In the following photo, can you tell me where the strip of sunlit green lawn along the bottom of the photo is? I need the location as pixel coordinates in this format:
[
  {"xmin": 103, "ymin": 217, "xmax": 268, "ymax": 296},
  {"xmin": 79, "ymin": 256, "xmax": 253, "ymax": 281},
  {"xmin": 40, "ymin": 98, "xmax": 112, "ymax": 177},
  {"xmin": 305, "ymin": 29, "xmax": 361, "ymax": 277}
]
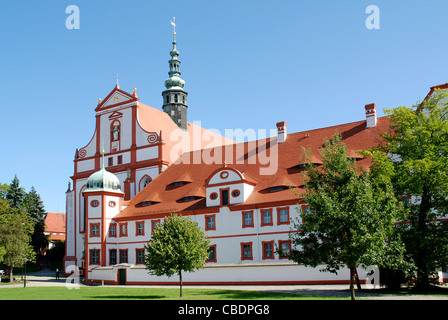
[{"xmin": 0, "ymin": 286, "xmax": 340, "ymax": 300}]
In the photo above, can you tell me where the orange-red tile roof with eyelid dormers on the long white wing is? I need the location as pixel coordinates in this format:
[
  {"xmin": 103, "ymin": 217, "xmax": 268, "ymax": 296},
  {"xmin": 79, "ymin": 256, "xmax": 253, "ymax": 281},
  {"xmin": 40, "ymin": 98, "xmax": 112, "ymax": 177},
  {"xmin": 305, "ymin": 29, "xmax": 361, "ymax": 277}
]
[{"xmin": 116, "ymin": 117, "xmax": 390, "ymax": 220}]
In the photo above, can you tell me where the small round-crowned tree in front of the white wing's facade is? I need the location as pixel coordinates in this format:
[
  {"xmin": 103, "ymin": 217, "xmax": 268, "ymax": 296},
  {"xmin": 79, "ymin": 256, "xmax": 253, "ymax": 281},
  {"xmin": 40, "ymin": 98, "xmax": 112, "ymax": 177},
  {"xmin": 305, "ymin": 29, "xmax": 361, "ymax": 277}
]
[{"xmin": 145, "ymin": 214, "xmax": 210, "ymax": 297}]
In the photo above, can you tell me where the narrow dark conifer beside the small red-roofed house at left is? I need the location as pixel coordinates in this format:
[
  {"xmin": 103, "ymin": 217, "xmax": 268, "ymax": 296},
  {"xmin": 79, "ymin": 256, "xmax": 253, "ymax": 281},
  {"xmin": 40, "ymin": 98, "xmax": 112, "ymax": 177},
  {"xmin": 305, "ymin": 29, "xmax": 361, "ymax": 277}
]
[{"xmin": 24, "ymin": 187, "xmax": 48, "ymax": 252}]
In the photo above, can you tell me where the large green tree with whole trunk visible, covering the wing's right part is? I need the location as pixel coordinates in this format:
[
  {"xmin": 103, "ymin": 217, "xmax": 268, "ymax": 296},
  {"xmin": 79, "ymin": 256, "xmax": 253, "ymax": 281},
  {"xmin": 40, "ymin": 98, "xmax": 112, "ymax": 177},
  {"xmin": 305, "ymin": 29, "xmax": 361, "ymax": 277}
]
[{"xmin": 290, "ymin": 134, "xmax": 403, "ymax": 299}]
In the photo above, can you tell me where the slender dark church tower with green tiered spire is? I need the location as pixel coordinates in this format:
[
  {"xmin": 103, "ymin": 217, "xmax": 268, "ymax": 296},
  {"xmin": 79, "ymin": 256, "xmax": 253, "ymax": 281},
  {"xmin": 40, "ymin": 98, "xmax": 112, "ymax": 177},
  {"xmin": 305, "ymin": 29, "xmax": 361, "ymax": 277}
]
[{"xmin": 162, "ymin": 18, "xmax": 188, "ymax": 130}]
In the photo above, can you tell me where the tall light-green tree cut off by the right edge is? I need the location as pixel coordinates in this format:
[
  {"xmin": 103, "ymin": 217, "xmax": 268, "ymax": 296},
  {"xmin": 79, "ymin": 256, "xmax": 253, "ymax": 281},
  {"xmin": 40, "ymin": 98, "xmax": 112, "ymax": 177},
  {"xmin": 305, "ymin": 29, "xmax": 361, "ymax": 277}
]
[{"xmin": 376, "ymin": 90, "xmax": 448, "ymax": 290}]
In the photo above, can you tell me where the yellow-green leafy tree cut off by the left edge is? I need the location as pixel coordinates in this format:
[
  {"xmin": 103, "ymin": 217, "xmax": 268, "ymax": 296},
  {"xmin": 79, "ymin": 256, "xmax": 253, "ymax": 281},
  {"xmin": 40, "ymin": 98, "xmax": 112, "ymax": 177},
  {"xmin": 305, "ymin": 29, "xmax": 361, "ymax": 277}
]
[{"xmin": 0, "ymin": 199, "xmax": 35, "ymax": 281}]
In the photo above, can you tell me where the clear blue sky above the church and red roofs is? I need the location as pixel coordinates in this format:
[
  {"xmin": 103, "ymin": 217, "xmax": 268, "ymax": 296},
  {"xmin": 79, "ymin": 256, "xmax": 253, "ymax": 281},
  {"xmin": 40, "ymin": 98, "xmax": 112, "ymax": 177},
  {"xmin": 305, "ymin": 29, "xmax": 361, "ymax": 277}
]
[{"xmin": 0, "ymin": 0, "xmax": 448, "ymax": 212}]
